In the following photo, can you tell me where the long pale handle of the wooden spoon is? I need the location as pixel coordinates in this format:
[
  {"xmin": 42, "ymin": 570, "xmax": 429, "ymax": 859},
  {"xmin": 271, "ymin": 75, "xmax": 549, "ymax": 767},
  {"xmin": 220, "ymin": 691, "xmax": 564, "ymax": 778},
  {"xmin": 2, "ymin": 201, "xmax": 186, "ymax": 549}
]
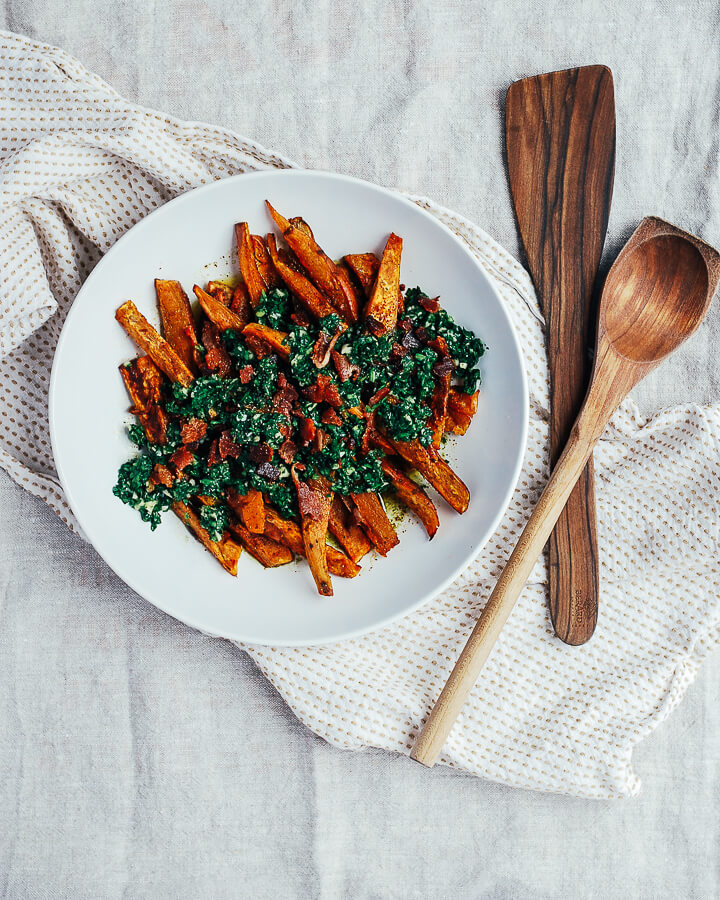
[{"xmin": 410, "ymin": 413, "xmax": 602, "ymax": 766}]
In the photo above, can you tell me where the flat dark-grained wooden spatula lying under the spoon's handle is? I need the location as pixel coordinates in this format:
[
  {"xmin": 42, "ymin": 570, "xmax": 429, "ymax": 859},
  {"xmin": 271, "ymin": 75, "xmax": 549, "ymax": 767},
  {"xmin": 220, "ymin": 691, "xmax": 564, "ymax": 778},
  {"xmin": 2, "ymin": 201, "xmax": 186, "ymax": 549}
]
[{"xmin": 505, "ymin": 66, "xmax": 615, "ymax": 644}]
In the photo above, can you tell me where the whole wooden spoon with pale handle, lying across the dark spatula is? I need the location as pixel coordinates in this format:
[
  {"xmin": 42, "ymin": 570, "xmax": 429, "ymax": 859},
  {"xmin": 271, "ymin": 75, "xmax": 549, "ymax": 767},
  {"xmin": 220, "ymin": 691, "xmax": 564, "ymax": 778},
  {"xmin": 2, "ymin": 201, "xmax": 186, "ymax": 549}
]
[{"xmin": 410, "ymin": 217, "xmax": 720, "ymax": 766}]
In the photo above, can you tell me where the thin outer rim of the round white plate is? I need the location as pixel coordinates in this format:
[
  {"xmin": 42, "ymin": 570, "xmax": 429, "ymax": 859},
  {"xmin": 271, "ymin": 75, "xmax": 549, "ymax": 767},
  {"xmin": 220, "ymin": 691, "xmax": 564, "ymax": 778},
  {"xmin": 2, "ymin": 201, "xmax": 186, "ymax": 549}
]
[{"xmin": 48, "ymin": 168, "xmax": 530, "ymax": 647}]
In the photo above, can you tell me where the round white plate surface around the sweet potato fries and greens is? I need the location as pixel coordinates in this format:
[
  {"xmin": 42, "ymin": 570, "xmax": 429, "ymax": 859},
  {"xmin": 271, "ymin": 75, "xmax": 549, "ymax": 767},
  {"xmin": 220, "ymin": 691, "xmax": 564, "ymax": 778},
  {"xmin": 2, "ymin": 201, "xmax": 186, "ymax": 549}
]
[{"xmin": 50, "ymin": 170, "xmax": 528, "ymax": 646}]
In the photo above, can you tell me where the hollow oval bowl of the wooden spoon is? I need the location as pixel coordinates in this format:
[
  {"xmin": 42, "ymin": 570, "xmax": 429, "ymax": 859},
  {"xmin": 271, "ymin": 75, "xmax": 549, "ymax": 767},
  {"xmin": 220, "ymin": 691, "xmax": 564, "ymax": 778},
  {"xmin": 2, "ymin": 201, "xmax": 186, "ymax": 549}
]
[{"xmin": 600, "ymin": 234, "xmax": 710, "ymax": 364}]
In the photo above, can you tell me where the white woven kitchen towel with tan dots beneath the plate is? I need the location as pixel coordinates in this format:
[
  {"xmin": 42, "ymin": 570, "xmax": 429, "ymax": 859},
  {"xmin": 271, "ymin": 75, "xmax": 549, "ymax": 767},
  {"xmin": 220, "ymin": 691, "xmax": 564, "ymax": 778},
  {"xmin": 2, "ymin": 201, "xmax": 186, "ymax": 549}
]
[{"xmin": 0, "ymin": 33, "xmax": 720, "ymax": 797}]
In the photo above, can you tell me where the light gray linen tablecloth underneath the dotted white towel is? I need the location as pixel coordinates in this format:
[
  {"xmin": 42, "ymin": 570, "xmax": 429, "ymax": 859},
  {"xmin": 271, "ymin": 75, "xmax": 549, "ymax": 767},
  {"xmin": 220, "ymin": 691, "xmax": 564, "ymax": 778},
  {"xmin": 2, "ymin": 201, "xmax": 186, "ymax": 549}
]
[{"xmin": 0, "ymin": 0, "xmax": 720, "ymax": 900}]
